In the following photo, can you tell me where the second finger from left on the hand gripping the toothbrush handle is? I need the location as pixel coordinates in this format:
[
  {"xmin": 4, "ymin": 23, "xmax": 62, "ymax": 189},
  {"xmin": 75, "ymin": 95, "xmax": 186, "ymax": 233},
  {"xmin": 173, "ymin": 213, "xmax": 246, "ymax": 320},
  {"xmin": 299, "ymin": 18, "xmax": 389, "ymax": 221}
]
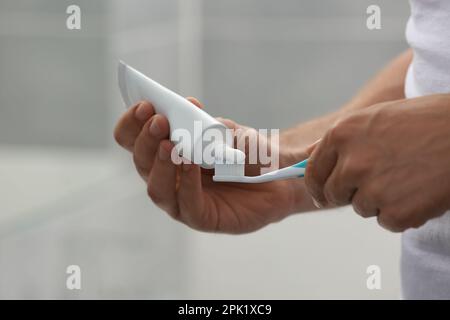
[{"xmin": 323, "ymin": 161, "xmax": 357, "ymax": 206}]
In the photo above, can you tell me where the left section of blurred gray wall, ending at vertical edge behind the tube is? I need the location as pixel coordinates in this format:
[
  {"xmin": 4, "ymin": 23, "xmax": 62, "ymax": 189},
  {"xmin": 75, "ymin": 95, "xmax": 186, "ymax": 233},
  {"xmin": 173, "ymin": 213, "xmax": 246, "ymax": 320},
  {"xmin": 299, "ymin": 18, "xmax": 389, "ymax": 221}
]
[{"xmin": 0, "ymin": 0, "xmax": 188, "ymax": 299}]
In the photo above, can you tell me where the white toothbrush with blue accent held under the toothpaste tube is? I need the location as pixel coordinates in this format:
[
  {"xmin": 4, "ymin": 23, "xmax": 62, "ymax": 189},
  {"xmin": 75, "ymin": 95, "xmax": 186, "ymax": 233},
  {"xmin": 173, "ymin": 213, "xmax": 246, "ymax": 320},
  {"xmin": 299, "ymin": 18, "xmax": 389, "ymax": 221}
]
[{"xmin": 213, "ymin": 159, "xmax": 308, "ymax": 183}]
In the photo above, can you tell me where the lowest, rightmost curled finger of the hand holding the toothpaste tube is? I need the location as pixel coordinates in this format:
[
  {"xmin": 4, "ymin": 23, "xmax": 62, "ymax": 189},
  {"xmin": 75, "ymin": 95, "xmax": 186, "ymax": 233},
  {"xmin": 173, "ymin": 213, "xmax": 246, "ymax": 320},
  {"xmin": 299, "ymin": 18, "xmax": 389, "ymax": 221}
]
[{"xmin": 177, "ymin": 163, "xmax": 210, "ymax": 230}]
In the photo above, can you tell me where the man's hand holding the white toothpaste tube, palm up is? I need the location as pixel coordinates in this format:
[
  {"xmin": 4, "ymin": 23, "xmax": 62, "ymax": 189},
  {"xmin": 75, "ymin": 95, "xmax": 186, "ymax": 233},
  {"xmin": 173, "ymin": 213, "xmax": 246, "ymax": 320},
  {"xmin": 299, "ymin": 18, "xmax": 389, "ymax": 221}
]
[{"xmin": 114, "ymin": 98, "xmax": 312, "ymax": 233}]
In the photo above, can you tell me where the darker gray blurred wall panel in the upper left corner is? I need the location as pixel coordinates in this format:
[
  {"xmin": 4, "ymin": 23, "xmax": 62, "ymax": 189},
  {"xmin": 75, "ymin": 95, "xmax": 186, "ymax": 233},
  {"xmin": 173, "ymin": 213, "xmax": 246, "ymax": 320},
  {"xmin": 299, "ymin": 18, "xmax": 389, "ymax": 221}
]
[{"xmin": 0, "ymin": 0, "xmax": 108, "ymax": 147}]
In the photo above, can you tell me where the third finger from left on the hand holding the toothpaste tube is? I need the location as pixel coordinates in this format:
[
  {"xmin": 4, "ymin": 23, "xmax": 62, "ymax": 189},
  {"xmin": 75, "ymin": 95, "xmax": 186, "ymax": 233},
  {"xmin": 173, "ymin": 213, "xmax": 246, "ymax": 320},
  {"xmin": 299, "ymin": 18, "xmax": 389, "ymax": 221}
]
[{"xmin": 147, "ymin": 140, "xmax": 179, "ymax": 219}]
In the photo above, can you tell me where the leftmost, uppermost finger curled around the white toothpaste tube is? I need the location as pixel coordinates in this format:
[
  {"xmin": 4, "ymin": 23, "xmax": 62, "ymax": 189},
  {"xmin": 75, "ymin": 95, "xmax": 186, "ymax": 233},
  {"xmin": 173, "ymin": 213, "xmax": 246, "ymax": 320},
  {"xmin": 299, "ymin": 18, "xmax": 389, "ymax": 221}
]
[{"xmin": 114, "ymin": 101, "xmax": 155, "ymax": 151}]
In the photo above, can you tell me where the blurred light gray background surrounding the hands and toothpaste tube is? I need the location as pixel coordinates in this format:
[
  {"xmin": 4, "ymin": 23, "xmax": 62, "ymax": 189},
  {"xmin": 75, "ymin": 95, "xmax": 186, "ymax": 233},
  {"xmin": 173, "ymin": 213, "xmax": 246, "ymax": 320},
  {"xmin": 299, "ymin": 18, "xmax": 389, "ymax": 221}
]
[{"xmin": 0, "ymin": 0, "xmax": 409, "ymax": 299}]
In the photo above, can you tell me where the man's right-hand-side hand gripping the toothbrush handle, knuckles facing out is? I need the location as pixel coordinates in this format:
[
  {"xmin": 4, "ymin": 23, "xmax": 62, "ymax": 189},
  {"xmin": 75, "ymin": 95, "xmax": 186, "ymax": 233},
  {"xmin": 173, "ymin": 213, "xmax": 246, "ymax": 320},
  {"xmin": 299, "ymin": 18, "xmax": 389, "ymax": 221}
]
[{"xmin": 305, "ymin": 95, "xmax": 450, "ymax": 232}]
